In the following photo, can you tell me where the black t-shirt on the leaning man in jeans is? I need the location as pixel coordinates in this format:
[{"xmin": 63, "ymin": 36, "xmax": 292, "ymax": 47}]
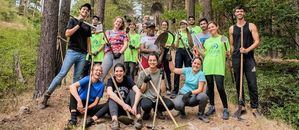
[{"xmin": 67, "ymin": 18, "xmax": 91, "ymax": 54}]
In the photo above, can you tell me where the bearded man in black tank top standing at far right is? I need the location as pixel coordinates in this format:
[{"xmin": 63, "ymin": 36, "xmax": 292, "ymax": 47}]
[{"xmin": 229, "ymin": 5, "xmax": 260, "ymax": 116}]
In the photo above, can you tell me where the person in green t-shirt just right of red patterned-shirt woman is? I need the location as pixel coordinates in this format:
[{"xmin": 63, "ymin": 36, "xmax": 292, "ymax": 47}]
[{"xmin": 124, "ymin": 22, "xmax": 140, "ymax": 81}]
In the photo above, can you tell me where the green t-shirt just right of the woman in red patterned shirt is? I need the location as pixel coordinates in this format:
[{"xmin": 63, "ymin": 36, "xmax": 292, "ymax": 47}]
[{"xmin": 124, "ymin": 33, "xmax": 140, "ymax": 62}]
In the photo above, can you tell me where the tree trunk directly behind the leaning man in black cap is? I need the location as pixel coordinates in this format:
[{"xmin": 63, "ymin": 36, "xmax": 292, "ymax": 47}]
[{"xmin": 55, "ymin": 0, "xmax": 71, "ymax": 74}]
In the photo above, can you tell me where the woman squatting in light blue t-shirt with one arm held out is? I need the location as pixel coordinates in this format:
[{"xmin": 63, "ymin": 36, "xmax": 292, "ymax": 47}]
[{"xmin": 169, "ymin": 58, "xmax": 209, "ymax": 123}]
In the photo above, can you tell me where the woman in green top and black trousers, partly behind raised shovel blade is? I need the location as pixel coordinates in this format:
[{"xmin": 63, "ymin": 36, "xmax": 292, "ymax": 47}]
[{"xmin": 157, "ymin": 20, "xmax": 175, "ymax": 95}]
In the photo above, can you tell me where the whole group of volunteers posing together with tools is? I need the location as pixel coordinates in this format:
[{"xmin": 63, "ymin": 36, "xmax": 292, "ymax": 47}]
[{"xmin": 41, "ymin": 4, "xmax": 259, "ymax": 129}]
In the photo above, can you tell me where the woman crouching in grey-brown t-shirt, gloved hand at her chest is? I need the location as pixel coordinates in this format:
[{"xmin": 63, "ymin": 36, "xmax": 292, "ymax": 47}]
[{"xmin": 137, "ymin": 53, "xmax": 174, "ymax": 120}]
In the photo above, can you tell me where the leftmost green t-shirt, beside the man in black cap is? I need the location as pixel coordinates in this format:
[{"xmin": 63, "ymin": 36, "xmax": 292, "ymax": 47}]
[{"xmin": 86, "ymin": 33, "xmax": 105, "ymax": 62}]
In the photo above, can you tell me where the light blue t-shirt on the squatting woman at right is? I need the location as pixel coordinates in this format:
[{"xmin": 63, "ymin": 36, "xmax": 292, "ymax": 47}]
[{"xmin": 180, "ymin": 67, "xmax": 206, "ymax": 94}]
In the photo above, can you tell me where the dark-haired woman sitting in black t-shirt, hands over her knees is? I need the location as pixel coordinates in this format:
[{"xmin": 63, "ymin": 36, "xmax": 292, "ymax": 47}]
[{"xmin": 107, "ymin": 63, "xmax": 143, "ymax": 130}]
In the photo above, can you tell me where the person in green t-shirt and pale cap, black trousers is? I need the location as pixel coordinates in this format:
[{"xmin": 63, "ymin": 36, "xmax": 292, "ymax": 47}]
[{"xmin": 170, "ymin": 20, "xmax": 193, "ymax": 98}]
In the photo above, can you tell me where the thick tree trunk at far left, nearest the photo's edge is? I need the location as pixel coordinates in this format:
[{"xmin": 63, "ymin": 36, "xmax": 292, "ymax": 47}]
[{"xmin": 33, "ymin": 0, "xmax": 59, "ymax": 98}]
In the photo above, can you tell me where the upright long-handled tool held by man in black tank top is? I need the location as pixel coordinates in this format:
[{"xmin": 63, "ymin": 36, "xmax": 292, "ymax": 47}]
[{"xmin": 234, "ymin": 27, "xmax": 244, "ymax": 120}]
